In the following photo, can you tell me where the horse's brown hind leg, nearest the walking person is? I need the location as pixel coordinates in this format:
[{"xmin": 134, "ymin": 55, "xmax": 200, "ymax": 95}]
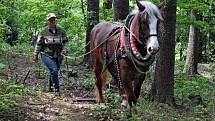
[{"xmin": 94, "ymin": 69, "xmax": 109, "ymax": 103}]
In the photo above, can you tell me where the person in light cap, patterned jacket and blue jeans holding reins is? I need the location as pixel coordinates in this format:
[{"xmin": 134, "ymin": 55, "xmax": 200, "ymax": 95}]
[{"xmin": 34, "ymin": 13, "xmax": 68, "ymax": 96}]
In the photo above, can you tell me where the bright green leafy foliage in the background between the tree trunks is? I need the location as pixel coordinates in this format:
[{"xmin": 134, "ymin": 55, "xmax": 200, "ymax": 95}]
[{"xmin": 0, "ymin": 0, "xmax": 215, "ymax": 60}]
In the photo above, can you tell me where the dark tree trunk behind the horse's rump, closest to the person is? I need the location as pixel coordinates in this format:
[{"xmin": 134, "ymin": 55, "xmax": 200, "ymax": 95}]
[{"xmin": 83, "ymin": 0, "xmax": 99, "ymax": 64}]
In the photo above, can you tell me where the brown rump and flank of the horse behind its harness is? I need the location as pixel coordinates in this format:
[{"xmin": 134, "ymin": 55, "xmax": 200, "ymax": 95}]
[{"xmin": 90, "ymin": 22, "xmax": 121, "ymax": 74}]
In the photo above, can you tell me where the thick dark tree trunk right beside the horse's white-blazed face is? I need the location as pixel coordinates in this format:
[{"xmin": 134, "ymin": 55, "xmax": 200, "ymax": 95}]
[{"xmin": 151, "ymin": 0, "xmax": 176, "ymax": 105}]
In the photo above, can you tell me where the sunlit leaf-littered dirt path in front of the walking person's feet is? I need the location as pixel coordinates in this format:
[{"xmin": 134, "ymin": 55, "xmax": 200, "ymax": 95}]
[{"xmin": 22, "ymin": 93, "xmax": 98, "ymax": 121}]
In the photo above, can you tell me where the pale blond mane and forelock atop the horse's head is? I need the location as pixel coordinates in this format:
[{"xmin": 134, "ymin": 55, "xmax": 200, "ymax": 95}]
[{"xmin": 132, "ymin": 1, "xmax": 163, "ymax": 20}]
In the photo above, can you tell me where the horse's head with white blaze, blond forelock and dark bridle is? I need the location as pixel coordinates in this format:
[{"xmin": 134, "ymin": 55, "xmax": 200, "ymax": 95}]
[{"xmin": 134, "ymin": 0, "xmax": 163, "ymax": 59}]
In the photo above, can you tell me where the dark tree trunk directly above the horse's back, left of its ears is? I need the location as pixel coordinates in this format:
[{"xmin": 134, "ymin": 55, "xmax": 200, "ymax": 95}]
[{"xmin": 113, "ymin": 0, "xmax": 129, "ymax": 21}]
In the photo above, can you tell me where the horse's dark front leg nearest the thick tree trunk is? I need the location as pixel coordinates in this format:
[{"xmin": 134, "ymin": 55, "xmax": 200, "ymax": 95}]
[{"xmin": 134, "ymin": 74, "xmax": 146, "ymax": 99}]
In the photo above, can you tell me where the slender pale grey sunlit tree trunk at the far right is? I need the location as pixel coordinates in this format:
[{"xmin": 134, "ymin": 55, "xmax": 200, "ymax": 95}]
[{"xmin": 183, "ymin": 11, "xmax": 200, "ymax": 79}]
